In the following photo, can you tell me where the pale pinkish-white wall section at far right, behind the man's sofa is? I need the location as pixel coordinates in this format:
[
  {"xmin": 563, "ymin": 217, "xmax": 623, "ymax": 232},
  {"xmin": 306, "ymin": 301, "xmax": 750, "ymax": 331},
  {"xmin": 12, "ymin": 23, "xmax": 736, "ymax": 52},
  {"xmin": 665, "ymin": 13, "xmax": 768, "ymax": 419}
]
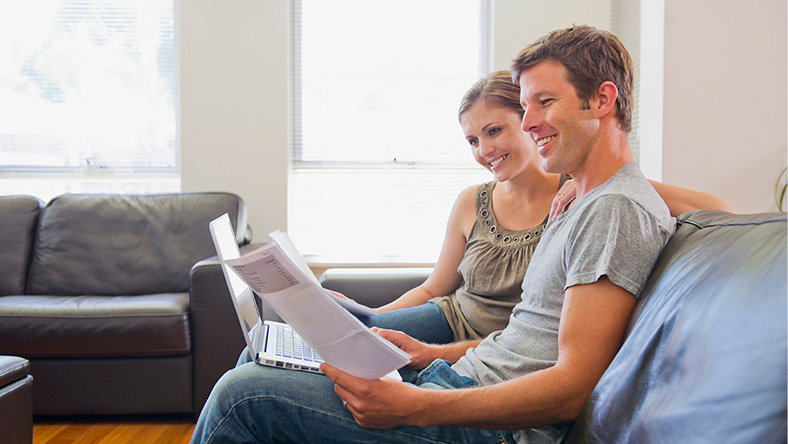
[{"xmin": 663, "ymin": 0, "xmax": 788, "ymax": 213}]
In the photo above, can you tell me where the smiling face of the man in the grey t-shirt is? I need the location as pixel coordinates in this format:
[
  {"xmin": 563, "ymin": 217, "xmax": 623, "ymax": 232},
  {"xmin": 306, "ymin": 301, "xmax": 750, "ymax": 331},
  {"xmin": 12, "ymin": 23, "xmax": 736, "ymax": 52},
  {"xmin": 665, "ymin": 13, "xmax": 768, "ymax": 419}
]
[{"xmin": 520, "ymin": 61, "xmax": 599, "ymax": 174}]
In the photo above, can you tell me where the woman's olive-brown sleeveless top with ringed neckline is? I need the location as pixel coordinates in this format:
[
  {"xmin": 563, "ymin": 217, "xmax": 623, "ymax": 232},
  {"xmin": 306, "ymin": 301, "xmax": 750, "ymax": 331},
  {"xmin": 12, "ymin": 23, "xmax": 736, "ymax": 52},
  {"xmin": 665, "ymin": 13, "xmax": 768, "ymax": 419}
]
[{"xmin": 432, "ymin": 177, "xmax": 566, "ymax": 341}]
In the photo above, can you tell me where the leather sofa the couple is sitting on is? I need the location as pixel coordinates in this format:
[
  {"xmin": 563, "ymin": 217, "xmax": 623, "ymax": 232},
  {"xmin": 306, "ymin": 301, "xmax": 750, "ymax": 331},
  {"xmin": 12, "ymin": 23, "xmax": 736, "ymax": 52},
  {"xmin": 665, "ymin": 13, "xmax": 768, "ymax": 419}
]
[{"xmin": 321, "ymin": 210, "xmax": 788, "ymax": 444}]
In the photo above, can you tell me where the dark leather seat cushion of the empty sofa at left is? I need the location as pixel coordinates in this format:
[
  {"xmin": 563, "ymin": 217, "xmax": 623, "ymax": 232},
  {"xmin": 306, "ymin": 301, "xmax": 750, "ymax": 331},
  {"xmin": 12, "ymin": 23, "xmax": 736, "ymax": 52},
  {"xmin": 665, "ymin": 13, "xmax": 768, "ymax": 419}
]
[{"xmin": 0, "ymin": 293, "xmax": 191, "ymax": 358}]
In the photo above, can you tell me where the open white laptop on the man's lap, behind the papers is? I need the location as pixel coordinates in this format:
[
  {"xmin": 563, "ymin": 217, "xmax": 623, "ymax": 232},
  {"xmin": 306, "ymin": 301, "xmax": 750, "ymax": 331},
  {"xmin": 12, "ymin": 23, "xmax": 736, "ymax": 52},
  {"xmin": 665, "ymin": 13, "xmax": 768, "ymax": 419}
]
[{"xmin": 210, "ymin": 214, "xmax": 323, "ymax": 373}]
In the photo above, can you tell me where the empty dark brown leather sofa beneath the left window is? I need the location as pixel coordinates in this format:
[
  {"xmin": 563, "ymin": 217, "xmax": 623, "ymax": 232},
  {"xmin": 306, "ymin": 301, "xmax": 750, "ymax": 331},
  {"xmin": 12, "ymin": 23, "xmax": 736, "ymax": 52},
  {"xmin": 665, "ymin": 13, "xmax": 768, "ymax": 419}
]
[{"xmin": 0, "ymin": 193, "xmax": 251, "ymax": 415}]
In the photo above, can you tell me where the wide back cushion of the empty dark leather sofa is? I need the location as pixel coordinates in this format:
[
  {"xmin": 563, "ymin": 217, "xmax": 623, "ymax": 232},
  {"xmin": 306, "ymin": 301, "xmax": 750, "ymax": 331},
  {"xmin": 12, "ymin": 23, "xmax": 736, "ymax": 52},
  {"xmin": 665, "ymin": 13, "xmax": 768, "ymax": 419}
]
[{"xmin": 27, "ymin": 193, "xmax": 246, "ymax": 296}]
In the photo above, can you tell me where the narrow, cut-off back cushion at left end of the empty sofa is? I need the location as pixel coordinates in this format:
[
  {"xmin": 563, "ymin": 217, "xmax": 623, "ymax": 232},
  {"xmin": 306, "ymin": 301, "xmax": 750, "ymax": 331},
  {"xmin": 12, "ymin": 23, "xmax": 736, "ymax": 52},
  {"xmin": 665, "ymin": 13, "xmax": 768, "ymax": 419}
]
[{"xmin": 0, "ymin": 196, "xmax": 43, "ymax": 296}]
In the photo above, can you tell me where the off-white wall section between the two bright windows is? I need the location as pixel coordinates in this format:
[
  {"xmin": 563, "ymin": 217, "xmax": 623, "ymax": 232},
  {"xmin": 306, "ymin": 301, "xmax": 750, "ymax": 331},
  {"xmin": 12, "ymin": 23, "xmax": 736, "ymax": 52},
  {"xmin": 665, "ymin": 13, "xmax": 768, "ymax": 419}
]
[{"xmin": 177, "ymin": 0, "xmax": 289, "ymax": 236}]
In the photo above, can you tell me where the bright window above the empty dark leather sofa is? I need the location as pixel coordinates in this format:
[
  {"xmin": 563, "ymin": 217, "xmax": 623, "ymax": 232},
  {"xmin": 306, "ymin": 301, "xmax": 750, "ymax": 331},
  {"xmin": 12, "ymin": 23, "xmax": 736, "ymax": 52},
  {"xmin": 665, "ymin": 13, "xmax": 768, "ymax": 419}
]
[{"xmin": 0, "ymin": 0, "xmax": 180, "ymax": 200}]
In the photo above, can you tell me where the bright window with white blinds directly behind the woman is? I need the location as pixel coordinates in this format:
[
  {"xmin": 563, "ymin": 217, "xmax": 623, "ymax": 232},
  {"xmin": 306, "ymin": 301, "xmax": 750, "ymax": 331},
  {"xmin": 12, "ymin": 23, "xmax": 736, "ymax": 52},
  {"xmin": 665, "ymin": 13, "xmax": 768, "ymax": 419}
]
[{"xmin": 288, "ymin": 0, "xmax": 491, "ymax": 264}]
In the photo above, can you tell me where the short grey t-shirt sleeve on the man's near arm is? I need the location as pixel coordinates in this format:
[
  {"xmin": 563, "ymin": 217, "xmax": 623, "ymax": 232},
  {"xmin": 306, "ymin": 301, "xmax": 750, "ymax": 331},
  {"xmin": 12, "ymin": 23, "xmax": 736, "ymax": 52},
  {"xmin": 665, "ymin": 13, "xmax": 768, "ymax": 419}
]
[{"xmin": 564, "ymin": 194, "xmax": 669, "ymax": 296}]
